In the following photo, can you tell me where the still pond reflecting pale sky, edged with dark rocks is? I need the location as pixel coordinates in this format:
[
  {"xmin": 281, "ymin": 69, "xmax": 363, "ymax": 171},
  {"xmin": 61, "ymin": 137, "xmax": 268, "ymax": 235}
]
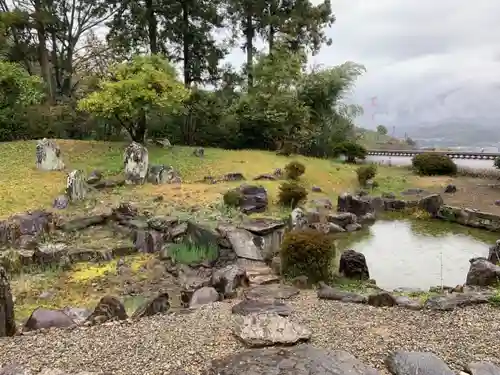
[{"xmin": 338, "ymin": 220, "xmax": 499, "ymax": 290}]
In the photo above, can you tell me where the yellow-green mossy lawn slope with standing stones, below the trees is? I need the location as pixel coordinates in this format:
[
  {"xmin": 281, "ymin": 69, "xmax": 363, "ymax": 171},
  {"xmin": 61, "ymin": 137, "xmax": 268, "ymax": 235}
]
[{"xmin": 0, "ymin": 140, "xmax": 425, "ymax": 218}]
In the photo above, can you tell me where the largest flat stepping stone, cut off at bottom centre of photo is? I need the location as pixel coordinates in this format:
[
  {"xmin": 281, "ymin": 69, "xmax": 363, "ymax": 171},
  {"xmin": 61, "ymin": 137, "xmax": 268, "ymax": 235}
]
[{"xmin": 203, "ymin": 344, "xmax": 378, "ymax": 375}]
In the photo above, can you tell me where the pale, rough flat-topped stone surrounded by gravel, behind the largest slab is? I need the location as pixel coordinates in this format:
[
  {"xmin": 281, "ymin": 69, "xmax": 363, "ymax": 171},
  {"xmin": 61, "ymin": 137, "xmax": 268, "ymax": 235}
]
[{"xmin": 233, "ymin": 313, "xmax": 311, "ymax": 347}]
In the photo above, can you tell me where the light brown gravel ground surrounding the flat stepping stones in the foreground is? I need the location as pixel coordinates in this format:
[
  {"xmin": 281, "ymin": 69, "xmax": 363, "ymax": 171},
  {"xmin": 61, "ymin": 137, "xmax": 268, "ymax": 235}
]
[{"xmin": 0, "ymin": 292, "xmax": 500, "ymax": 375}]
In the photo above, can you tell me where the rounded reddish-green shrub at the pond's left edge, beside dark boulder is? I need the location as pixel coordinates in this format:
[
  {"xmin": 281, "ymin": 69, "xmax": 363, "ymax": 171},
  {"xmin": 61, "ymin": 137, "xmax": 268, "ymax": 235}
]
[{"xmin": 280, "ymin": 229, "xmax": 336, "ymax": 283}]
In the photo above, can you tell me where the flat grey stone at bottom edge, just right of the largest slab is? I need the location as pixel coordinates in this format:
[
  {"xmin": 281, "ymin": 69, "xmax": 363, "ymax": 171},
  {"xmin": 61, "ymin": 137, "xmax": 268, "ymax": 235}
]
[{"xmin": 384, "ymin": 351, "xmax": 454, "ymax": 375}]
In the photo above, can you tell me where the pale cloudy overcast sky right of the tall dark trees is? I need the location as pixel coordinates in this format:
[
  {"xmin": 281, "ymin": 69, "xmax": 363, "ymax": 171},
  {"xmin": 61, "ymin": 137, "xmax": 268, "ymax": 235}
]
[{"xmin": 229, "ymin": 0, "xmax": 500, "ymax": 130}]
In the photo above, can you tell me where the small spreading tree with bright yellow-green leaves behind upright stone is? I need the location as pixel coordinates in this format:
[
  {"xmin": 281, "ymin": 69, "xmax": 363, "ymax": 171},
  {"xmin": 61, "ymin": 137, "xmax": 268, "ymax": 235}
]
[{"xmin": 78, "ymin": 55, "xmax": 189, "ymax": 143}]
